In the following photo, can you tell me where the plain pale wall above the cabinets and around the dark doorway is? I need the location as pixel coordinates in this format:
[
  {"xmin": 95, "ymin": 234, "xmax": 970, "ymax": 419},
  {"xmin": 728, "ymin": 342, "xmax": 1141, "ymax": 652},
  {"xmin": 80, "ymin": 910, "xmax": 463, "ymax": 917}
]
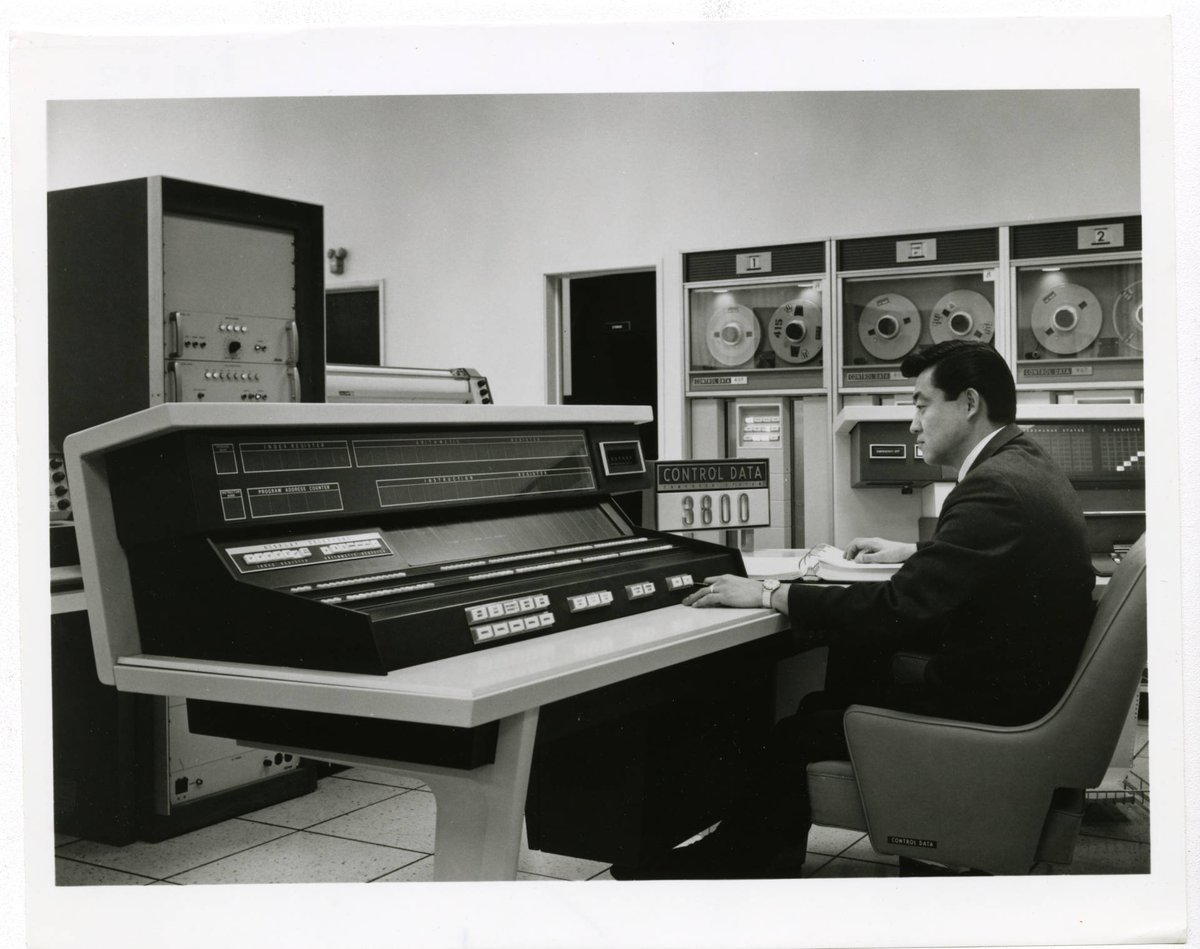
[{"xmin": 48, "ymin": 90, "xmax": 1140, "ymax": 457}]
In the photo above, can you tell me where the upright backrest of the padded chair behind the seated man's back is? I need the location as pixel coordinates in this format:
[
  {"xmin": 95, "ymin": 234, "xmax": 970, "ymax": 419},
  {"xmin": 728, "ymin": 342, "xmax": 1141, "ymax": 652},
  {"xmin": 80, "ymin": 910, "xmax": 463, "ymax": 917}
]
[{"xmin": 1036, "ymin": 535, "xmax": 1146, "ymax": 788}]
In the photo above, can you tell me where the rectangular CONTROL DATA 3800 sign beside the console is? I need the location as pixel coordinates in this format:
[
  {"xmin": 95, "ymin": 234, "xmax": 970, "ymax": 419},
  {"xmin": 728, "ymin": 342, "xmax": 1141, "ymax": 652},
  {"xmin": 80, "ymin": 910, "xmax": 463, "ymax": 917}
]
[{"xmin": 654, "ymin": 458, "xmax": 770, "ymax": 530}]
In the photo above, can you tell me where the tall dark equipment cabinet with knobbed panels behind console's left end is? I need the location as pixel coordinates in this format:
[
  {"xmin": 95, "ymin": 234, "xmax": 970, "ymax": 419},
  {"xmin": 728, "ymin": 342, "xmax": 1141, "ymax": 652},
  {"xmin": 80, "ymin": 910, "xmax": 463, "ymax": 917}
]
[{"xmin": 47, "ymin": 176, "xmax": 325, "ymax": 843}]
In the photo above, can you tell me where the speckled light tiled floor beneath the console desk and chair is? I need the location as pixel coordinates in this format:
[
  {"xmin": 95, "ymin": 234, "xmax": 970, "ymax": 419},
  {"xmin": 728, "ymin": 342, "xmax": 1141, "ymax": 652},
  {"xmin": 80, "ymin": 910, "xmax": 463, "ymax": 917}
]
[{"xmin": 55, "ymin": 728, "xmax": 1150, "ymax": 887}]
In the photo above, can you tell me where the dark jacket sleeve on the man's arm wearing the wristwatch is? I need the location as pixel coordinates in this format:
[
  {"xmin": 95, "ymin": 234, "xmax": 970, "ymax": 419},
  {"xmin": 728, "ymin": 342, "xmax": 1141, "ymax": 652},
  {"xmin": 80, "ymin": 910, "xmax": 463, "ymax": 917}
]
[{"xmin": 788, "ymin": 472, "xmax": 1027, "ymax": 645}]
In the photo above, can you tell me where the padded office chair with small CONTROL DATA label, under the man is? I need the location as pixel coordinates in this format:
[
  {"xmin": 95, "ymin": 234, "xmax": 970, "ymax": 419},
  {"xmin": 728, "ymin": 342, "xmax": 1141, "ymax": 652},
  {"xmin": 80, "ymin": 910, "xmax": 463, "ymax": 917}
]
[{"xmin": 808, "ymin": 535, "xmax": 1146, "ymax": 873}]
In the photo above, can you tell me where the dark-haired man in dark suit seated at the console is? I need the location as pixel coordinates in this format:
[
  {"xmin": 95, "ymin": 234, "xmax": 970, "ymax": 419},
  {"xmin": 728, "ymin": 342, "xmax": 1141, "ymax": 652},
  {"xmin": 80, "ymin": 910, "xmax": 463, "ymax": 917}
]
[{"xmin": 613, "ymin": 341, "xmax": 1094, "ymax": 878}]
